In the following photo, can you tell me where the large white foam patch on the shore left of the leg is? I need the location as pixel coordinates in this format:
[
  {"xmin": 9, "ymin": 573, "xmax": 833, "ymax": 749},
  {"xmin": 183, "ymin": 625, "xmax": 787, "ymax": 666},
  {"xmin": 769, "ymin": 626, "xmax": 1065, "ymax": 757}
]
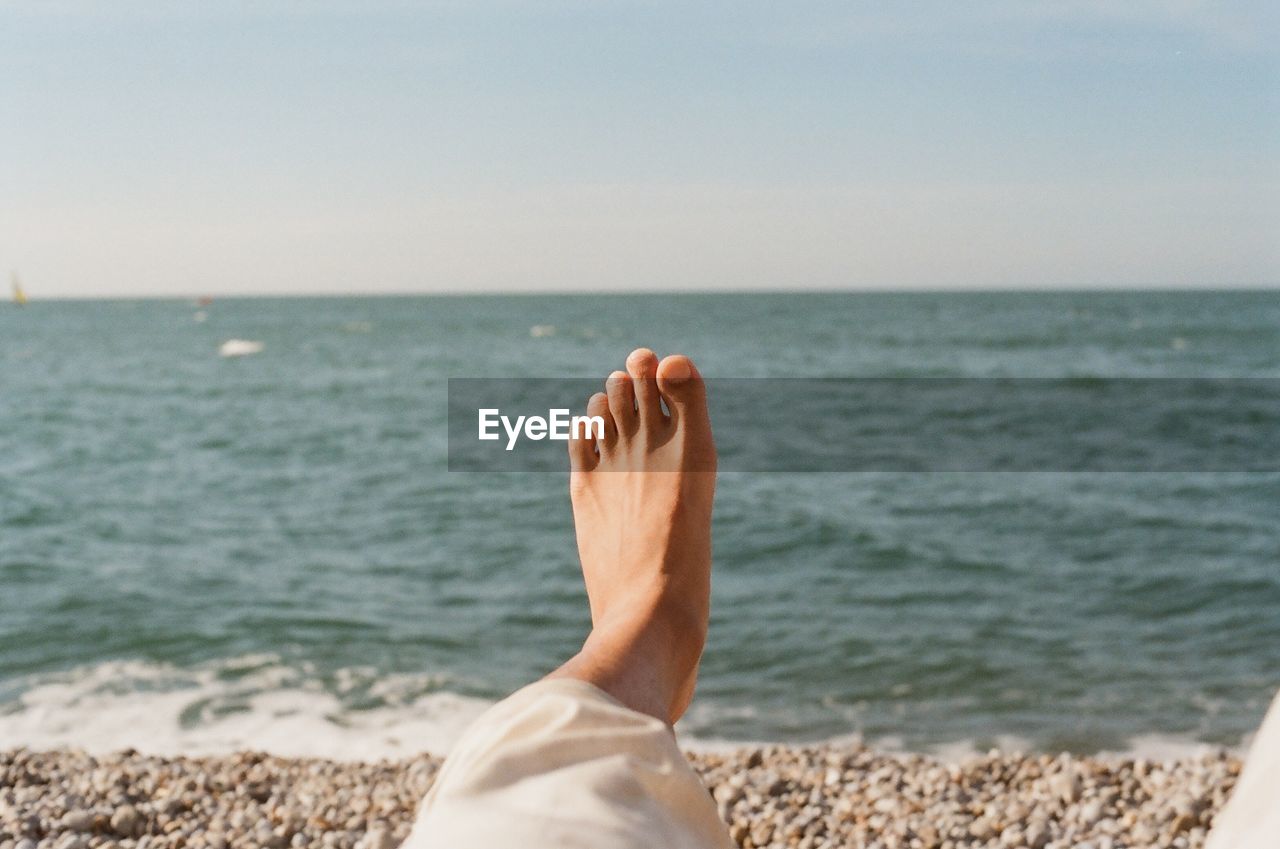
[{"xmin": 0, "ymin": 656, "xmax": 488, "ymax": 761}]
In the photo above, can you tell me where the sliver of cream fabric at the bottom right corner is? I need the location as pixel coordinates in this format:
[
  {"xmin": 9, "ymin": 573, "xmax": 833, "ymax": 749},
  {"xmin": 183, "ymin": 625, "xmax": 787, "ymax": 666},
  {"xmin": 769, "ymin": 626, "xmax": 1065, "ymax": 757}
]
[{"xmin": 1204, "ymin": 693, "xmax": 1280, "ymax": 849}]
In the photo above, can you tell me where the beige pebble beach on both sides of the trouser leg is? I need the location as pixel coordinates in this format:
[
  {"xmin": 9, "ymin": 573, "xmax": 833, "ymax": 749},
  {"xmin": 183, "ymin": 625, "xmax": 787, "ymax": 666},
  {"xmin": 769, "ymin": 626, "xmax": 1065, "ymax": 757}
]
[{"xmin": 0, "ymin": 744, "xmax": 1240, "ymax": 849}]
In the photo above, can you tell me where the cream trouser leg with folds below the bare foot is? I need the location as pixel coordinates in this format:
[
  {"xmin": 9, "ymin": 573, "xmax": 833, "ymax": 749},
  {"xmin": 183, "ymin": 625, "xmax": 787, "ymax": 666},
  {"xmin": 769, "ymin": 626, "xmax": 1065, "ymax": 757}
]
[{"xmin": 404, "ymin": 679, "xmax": 733, "ymax": 849}]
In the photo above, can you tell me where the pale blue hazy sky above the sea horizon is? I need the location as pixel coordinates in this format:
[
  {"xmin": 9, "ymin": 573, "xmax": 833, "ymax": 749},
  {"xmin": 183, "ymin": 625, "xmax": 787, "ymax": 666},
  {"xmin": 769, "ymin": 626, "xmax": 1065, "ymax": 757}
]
[{"xmin": 0, "ymin": 0, "xmax": 1280, "ymax": 297}]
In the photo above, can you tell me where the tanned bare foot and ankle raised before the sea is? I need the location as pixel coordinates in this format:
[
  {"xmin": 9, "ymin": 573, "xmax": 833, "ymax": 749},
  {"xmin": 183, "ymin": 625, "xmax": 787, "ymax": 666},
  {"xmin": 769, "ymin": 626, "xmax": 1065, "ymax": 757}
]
[{"xmin": 552, "ymin": 348, "xmax": 716, "ymax": 724}]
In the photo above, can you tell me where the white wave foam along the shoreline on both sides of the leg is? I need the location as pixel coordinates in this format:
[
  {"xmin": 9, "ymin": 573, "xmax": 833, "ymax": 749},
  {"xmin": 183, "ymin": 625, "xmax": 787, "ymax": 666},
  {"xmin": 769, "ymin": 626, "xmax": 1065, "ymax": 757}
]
[{"xmin": 0, "ymin": 654, "xmax": 1247, "ymax": 762}]
